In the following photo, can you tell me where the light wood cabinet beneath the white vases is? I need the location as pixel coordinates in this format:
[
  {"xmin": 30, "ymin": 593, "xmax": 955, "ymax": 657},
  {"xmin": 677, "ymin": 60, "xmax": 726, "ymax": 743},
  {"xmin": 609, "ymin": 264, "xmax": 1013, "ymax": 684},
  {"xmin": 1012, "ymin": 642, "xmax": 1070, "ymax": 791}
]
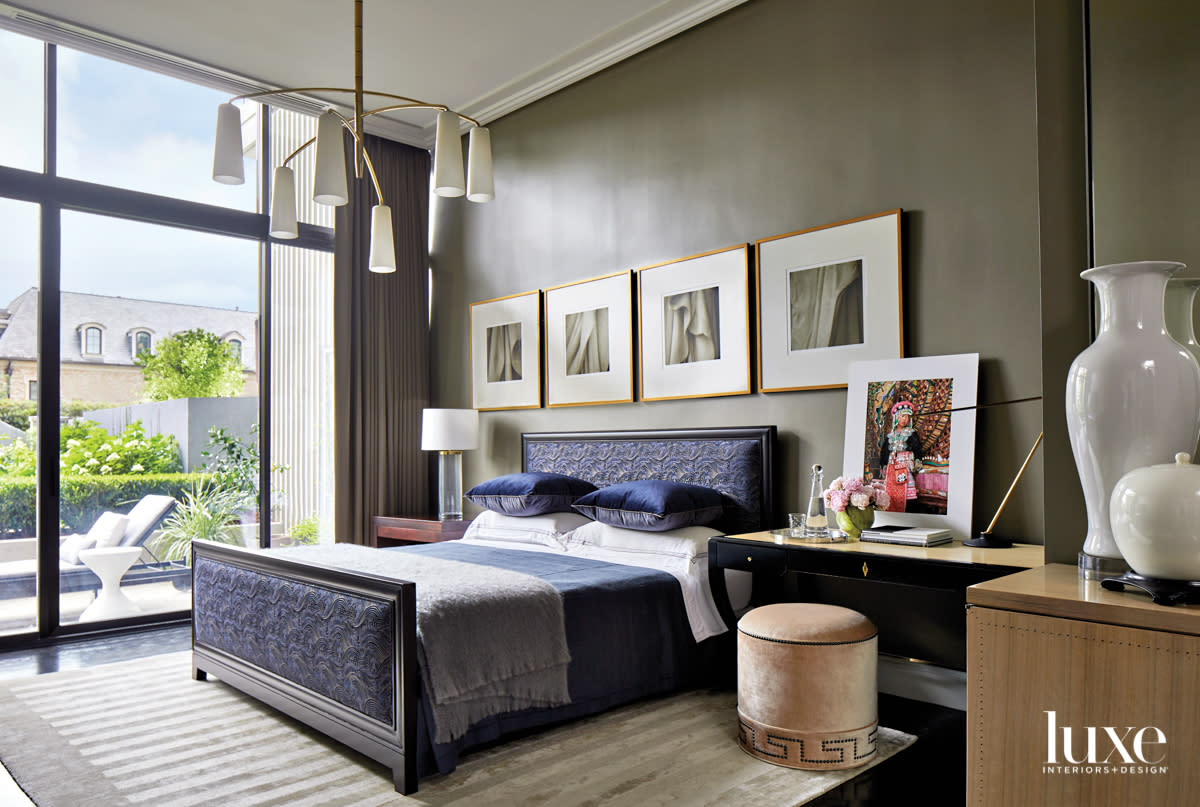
[{"xmin": 967, "ymin": 564, "xmax": 1200, "ymax": 807}]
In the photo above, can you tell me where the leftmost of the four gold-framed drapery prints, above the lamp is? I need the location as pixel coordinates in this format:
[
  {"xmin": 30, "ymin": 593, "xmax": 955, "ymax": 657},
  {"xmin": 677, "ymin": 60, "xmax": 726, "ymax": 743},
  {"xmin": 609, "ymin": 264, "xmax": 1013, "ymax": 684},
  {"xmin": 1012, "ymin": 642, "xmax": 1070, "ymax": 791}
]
[{"xmin": 470, "ymin": 292, "xmax": 541, "ymax": 410}]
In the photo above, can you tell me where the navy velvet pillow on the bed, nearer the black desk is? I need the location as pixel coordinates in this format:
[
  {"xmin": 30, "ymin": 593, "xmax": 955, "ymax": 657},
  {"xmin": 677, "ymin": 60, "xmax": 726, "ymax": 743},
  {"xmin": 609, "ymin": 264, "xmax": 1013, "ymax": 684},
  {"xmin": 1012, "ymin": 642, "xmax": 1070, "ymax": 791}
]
[{"xmin": 574, "ymin": 479, "xmax": 724, "ymax": 532}]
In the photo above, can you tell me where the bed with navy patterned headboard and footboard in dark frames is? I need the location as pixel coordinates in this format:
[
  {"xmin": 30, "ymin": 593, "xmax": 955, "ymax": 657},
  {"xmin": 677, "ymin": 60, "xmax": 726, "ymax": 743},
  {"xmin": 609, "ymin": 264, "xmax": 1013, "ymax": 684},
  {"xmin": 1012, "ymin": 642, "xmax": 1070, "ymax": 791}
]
[{"xmin": 192, "ymin": 426, "xmax": 775, "ymax": 793}]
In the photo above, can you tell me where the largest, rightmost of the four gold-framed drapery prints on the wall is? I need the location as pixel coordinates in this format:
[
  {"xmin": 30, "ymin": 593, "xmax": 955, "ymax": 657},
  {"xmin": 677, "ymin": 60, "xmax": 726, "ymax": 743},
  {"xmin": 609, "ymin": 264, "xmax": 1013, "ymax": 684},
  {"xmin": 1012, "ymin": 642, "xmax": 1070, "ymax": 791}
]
[{"xmin": 755, "ymin": 210, "xmax": 904, "ymax": 393}]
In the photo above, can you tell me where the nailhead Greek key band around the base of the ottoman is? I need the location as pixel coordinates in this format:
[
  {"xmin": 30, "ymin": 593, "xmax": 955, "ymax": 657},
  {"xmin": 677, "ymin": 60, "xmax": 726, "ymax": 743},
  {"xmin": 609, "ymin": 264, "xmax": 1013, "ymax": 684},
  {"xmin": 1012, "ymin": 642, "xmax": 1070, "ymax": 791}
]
[{"xmin": 738, "ymin": 709, "xmax": 880, "ymax": 770}]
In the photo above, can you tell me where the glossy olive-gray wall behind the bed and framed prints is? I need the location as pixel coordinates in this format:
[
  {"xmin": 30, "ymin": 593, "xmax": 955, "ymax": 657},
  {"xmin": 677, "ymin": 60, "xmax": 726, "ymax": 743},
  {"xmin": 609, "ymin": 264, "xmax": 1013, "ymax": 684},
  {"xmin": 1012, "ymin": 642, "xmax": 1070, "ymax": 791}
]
[{"xmin": 432, "ymin": 0, "xmax": 1086, "ymax": 552}]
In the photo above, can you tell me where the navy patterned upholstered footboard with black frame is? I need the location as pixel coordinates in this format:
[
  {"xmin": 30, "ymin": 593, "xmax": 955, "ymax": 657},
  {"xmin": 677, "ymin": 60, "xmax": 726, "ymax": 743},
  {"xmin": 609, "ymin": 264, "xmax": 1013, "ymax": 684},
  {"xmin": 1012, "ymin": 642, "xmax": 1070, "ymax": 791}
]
[{"xmin": 184, "ymin": 540, "xmax": 420, "ymax": 793}]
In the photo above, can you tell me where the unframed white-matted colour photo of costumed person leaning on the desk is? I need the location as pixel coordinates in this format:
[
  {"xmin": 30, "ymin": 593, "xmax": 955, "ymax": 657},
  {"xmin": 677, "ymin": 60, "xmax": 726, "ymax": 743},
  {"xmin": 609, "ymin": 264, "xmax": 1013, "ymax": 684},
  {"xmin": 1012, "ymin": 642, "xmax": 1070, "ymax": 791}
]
[{"xmin": 842, "ymin": 353, "xmax": 979, "ymax": 539}]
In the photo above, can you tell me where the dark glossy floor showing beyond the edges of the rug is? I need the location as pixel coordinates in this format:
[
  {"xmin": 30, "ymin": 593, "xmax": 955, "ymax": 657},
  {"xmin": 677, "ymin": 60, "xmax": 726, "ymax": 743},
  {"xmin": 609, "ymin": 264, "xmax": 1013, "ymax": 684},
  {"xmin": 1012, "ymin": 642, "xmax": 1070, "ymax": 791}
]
[{"xmin": 0, "ymin": 624, "xmax": 966, "ymax": 807}]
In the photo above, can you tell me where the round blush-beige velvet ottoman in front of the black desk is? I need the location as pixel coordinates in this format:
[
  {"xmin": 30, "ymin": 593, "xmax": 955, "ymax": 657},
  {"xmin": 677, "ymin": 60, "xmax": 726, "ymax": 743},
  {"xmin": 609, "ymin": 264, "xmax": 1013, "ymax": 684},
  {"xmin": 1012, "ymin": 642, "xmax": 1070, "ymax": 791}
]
[{"xmin": 738, "ymin": 603, "xmax": 878, "ymax": 770}]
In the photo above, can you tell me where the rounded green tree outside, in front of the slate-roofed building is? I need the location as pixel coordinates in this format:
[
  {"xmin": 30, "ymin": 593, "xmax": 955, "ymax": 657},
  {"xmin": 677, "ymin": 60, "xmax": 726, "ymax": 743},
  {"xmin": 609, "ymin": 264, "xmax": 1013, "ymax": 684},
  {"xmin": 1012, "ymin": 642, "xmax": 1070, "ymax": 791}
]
[{"xmin": 137, "ymin": 328, "xmax": 246, "ymax": 401}]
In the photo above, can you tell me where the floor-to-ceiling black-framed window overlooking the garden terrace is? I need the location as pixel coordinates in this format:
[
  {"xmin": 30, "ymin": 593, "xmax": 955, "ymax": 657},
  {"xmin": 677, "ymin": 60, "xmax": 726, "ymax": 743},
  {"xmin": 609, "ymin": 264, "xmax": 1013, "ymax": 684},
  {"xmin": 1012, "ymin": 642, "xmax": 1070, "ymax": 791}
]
[{"xmin": 0, "ymin": 30, "xmax": 332, "ymax": 639}]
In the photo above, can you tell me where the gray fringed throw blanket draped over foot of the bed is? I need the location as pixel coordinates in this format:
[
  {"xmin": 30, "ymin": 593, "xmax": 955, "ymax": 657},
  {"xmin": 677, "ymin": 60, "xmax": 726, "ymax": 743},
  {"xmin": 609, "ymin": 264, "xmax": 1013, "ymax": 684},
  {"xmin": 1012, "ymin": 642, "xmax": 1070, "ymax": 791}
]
[{"xmin": 277, "ymin": 544, "xmax": 571, "ymax": 742}]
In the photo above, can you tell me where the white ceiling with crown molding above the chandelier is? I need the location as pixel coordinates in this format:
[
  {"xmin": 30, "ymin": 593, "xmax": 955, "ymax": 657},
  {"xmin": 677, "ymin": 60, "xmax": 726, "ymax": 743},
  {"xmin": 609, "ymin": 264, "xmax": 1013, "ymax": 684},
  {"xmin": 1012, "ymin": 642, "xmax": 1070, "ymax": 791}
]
[{"xmin": 0, "ymin": 0, "xmax": 744, "ymax": 145}]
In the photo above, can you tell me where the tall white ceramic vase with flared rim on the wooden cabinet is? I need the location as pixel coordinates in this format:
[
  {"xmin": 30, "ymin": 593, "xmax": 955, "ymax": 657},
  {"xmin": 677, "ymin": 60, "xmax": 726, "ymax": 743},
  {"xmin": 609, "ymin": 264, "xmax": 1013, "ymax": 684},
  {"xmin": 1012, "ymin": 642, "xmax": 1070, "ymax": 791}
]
[{"xmin": 1067, "ymin": 261, "xmax": 1200, "ymax": 558}]
